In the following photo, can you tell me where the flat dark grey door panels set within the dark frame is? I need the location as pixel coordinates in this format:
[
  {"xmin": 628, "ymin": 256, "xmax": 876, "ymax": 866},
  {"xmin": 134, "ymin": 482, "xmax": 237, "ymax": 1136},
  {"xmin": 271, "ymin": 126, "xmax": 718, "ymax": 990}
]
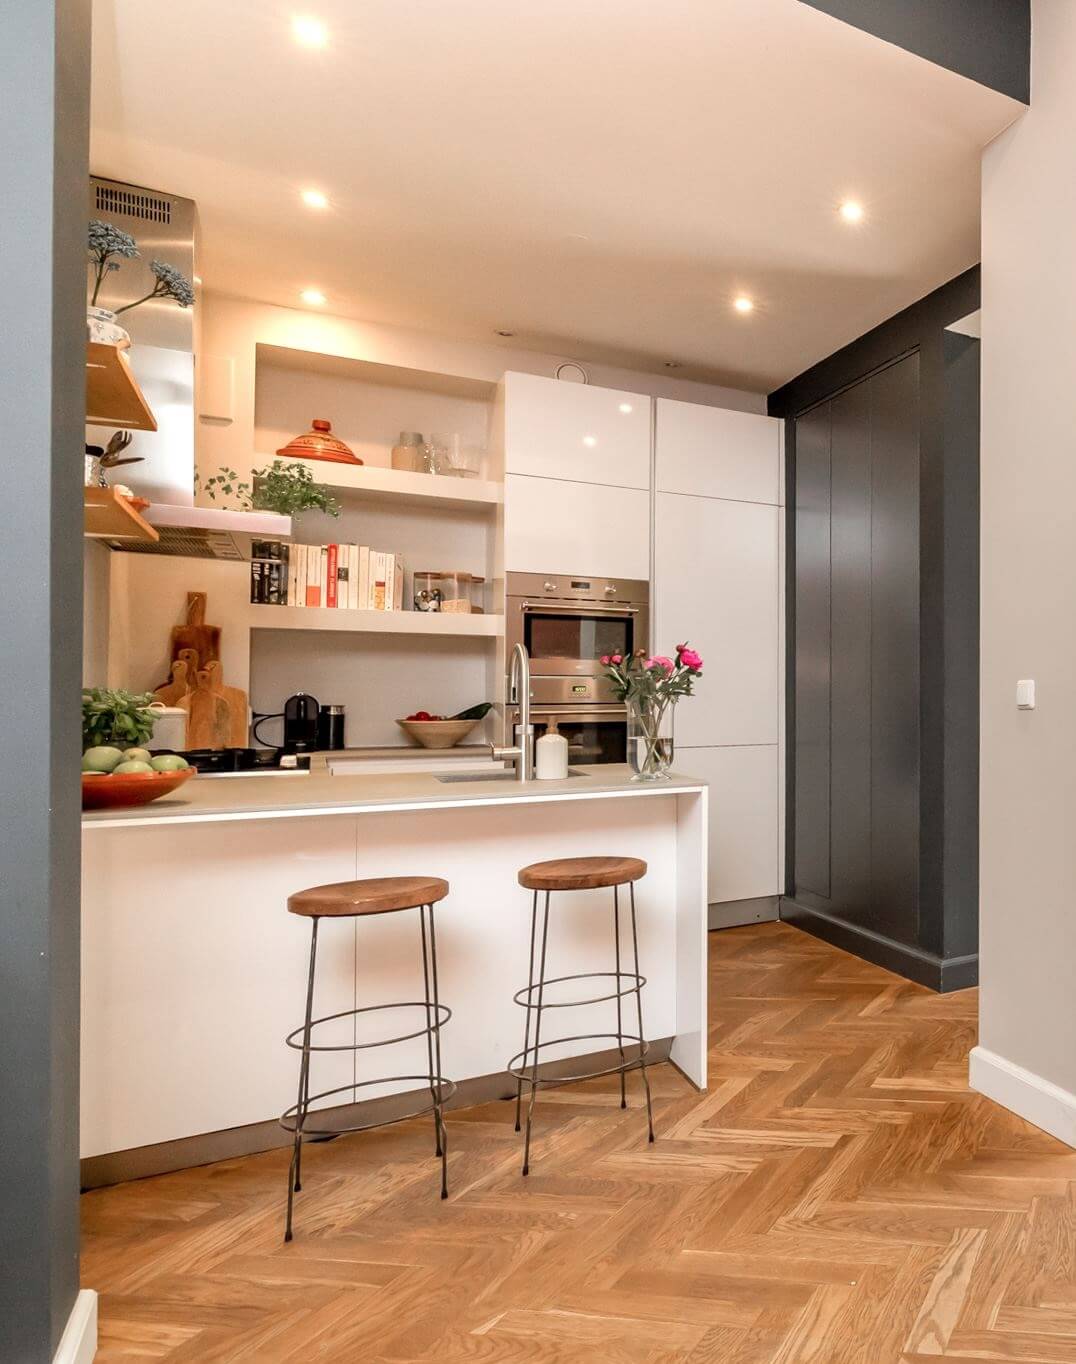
[{"xmin": 791, "ymin": 355, "xmax": 919, "ymax": 943}]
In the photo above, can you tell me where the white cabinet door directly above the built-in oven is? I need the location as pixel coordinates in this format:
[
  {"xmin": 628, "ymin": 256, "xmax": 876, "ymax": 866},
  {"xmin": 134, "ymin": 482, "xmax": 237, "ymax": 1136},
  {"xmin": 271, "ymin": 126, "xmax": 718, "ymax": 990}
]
[{"xmin": 505, "ymin": 473, "xmax": 651, "ymax": 580}]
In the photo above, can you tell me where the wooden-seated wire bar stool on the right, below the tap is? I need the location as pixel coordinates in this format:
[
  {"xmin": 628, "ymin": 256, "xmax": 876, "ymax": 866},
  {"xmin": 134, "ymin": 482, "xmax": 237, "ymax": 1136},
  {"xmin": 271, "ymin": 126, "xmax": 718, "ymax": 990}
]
[{"xmin": 507, "ymin": 857, "xmax": 653, "ymax": 1174}]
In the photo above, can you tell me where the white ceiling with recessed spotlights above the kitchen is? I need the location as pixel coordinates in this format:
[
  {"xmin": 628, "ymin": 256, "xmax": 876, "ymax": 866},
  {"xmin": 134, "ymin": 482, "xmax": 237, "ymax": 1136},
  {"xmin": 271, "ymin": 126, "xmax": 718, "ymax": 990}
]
[{"xmin": 91, "ymin": 0, "xmax": 1020, "ymax": 390}]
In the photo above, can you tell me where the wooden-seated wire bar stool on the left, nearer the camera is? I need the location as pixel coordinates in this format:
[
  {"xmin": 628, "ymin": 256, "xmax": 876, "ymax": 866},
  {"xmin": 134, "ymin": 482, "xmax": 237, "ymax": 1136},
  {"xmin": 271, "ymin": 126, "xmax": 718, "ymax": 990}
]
[{"xmin": 280, "ymin": 876, "xmax": 455, "ymax": 1241}]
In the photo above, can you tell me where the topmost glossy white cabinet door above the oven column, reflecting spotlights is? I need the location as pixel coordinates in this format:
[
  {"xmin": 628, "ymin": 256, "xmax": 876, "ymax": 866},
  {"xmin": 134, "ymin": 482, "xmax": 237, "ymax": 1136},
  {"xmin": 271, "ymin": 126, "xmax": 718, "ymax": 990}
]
[{"xmin": 505, "ymin": 374, "xmax": 651, "ymax": 488}]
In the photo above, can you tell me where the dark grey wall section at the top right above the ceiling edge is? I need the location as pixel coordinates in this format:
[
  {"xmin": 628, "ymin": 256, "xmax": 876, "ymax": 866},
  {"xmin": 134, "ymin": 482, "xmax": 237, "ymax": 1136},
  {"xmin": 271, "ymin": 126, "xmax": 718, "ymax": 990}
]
[{"xmin": 802, "ymin": 0, "xmax": 1031, "ymax": 104}]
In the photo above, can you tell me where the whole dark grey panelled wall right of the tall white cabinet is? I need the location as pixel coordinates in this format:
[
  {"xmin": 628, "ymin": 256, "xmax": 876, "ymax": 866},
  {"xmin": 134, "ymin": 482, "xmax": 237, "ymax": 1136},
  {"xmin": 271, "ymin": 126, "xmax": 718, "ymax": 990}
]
[{"xmin": 769, "ymin": 269, "xmax": 979, "ymax": 989}]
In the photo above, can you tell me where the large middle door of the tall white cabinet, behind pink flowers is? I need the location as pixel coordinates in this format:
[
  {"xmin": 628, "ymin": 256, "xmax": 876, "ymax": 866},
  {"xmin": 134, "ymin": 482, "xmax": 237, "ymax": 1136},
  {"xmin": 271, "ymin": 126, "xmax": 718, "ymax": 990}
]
[{"xmin": 652, "ymin": 492, "xmax": 781, "ymax": 746}]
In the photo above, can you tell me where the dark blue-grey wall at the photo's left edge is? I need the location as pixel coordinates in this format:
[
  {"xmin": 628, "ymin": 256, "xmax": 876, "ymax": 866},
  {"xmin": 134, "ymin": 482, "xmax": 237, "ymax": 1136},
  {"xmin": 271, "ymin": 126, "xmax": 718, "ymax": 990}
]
[{"xmin": 0, "ymin": 0, "xmax": 90, "ymax": 1364}]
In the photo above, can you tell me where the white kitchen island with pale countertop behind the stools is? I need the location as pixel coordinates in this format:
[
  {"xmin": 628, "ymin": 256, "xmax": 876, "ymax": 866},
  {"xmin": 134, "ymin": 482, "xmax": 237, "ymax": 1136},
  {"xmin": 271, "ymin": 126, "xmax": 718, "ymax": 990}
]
[{"xmin": 82, "ymin": 767, "xmax": 706, "ymax": 1183}]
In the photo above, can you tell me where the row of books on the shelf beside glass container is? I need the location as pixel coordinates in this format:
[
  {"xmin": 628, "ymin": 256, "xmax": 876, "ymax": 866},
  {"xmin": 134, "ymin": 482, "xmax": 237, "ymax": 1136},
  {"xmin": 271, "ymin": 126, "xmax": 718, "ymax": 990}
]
[{"xmin": 251, "ymin": 540, "xmax": 404, "ymax": 611}]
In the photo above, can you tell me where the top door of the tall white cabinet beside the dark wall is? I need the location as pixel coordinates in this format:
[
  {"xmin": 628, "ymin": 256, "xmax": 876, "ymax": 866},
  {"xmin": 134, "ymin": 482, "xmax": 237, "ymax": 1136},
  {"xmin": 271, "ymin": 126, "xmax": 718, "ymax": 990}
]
[{"xmin": 655, "ymin": 398, "xmax": 781, "ymax": 503}]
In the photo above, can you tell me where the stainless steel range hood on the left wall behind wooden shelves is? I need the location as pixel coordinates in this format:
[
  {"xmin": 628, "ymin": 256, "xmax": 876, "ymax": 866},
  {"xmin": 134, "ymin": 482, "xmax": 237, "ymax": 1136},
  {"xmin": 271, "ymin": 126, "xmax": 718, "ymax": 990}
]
[{"xmin": 86, "ymin": 176, "xmax": 292, "ymax": 559}]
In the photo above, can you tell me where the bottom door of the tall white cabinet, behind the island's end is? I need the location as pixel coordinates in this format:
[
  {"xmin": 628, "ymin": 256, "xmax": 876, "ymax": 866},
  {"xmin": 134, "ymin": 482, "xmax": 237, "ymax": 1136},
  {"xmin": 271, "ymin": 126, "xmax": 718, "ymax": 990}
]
[{"xmin": 675, "ymin": 747, "xmax": 780, "ymax": 904}]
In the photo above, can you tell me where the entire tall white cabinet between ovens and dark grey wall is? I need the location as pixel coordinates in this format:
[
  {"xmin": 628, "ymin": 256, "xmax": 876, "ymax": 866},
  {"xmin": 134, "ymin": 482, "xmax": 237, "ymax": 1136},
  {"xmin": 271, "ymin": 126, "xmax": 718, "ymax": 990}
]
[{"xmin": 652, "ymin": 398, "xmax": 783, "ymax": 918}]
